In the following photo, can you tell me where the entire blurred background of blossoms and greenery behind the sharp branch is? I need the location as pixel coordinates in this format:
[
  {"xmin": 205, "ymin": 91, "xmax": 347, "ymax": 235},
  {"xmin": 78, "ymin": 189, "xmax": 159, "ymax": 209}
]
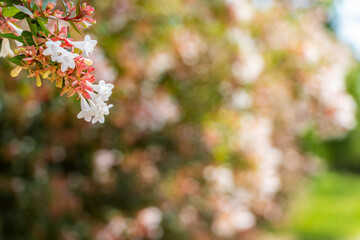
[{"xmin": 0, "ymin": 0, "xmax": 360, "ymax": 240}]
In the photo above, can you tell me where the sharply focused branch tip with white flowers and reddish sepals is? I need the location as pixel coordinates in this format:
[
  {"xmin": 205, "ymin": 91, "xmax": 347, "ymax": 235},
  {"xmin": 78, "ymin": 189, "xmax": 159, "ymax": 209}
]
[{"xmin": 0, "ymin": 1, "xmax": 114, "ymax": 123}]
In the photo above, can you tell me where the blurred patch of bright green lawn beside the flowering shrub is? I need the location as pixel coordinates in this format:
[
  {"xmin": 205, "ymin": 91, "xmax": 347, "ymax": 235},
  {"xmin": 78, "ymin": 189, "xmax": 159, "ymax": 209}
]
[{"xmin": 285, "ymin": 173, "xmax": 360, "ymax": 240}]
